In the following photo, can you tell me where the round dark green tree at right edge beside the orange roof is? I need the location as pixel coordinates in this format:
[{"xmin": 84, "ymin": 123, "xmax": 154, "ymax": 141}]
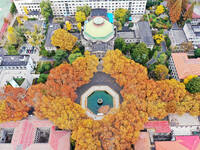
[{"xmin": 186, "ymin": 77, "xmax": 200, "ymax": 93}]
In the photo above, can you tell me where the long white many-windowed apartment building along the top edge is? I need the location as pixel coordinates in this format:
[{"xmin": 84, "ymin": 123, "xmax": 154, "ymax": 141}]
[{"xmin": 14, "ymin": 0, "xmax": 147, "ymax": 16}]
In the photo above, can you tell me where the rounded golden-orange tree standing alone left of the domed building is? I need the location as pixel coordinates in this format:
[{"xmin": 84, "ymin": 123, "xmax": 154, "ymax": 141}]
[{"xmin": 51, "ymin": 29, "xmax": 78, "ymax": 51}]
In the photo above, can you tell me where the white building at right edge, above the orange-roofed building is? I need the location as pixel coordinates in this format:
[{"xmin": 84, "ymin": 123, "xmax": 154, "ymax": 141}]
[{"xmin": 183, "ymin": 22, "xmax": 200, "ymax": 46}]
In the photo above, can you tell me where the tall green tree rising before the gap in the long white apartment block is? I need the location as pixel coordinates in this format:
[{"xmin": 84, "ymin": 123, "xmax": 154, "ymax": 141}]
[{"xmin": 40, "ymin": 0, "xmax": 53, "ymax": 22}]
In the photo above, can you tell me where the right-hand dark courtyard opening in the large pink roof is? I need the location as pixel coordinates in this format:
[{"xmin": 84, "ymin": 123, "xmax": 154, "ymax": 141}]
[{"xmin": 34, "ymin": 128, "xmax": 50, "ymax": 143}]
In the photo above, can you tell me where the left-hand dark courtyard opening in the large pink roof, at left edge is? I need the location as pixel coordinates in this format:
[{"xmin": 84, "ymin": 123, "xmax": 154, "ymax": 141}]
[{"xmin": 0, "ymin": 128, "xmax": 14, "ymax": 143}]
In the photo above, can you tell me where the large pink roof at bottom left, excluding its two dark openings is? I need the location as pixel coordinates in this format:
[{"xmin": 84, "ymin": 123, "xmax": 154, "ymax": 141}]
[{"xmin": 0, "ymin": 117, "xmax": 70, "ymax": 150}]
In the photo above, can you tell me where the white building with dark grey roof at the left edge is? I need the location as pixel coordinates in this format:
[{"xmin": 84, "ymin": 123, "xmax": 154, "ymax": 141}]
[{"xmin": 0, "ymin": 55, "xmax": 35, "ymax": 89}]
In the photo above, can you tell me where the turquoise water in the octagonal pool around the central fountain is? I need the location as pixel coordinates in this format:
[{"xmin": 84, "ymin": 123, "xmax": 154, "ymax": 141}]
[{"xmin": 87, "ymin": 91, "xmax": 113, "ymax": 114}]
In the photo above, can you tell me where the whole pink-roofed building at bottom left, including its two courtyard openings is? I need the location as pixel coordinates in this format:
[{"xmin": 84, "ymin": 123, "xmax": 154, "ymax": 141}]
[{"xmin": 0, "ymin": 117, "xmax": 70, "ymax": 150}]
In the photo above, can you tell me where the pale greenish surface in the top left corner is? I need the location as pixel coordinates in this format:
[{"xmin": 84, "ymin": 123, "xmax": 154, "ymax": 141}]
[{"xmin": 0, "ymin": 0, "xmax": 11, "ymax": 29}]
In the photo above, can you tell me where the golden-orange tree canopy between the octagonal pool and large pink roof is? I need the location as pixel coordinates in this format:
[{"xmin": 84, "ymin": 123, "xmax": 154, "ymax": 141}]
[{"xmin": 35, "ymin": 96, "xmax": 87, "ymax": 130}]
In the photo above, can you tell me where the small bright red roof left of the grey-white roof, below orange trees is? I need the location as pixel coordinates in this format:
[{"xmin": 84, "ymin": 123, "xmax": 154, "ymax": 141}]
[{"xmin": 144, "ymin": 121, "xmax": 171, "ymax": 133}]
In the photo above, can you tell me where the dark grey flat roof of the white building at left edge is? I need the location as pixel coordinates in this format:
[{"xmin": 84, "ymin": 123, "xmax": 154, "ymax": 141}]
[{"xmin": 0, "ymin": 55, "xmax": 30, "ymax": 66}]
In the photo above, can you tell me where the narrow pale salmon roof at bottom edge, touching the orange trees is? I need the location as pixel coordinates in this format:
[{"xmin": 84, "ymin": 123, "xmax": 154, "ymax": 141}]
[{"xmin": 134, "ymin": 132, "xmax": 151, "ymax": 150}]
